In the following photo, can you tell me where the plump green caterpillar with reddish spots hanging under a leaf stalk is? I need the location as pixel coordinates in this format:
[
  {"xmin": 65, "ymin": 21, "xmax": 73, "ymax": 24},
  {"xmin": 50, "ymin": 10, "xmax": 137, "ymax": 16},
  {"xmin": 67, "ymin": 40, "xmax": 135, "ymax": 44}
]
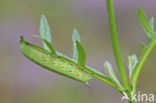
[{"xmin": 20, "ymin": 37, "xmax": 93, "ymax": 83}]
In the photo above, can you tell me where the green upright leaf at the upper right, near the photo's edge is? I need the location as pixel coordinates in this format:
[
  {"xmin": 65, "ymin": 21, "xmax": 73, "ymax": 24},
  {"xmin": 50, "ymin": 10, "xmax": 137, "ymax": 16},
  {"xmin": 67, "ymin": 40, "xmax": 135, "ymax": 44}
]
[{"xmin": 137, "ymin": 7, "xmax": 156, "ymax": 40}]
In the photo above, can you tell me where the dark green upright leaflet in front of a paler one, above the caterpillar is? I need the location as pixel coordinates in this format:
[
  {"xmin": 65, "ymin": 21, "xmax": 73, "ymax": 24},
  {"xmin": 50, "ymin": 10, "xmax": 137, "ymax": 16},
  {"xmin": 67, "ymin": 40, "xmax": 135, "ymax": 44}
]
[{"xmin": 76, "ymin": 41, "xmax": 86, "ymax": 66}]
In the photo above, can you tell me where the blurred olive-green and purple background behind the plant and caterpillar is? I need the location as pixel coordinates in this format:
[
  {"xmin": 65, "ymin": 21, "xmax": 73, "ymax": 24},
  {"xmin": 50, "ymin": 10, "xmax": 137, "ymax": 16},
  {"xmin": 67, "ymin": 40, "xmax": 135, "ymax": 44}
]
[{"xmin": 0, "ymin": 0, "xmax": 156, "ymax": 103}]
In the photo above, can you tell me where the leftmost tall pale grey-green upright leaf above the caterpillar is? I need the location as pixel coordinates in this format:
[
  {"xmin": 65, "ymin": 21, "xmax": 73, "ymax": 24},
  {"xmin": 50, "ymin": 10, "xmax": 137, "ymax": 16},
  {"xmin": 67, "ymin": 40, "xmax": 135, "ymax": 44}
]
[{"xmin": 40, "ymin": 15, "xmax": 52, "ymax": 51}]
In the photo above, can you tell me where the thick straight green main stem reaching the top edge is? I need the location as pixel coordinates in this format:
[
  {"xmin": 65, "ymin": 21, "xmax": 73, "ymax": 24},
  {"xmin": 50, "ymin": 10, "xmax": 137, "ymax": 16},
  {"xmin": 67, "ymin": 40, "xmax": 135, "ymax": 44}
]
[{"xmin": 106, "ymin": 0, "xmax": 129, "ymax": 89}]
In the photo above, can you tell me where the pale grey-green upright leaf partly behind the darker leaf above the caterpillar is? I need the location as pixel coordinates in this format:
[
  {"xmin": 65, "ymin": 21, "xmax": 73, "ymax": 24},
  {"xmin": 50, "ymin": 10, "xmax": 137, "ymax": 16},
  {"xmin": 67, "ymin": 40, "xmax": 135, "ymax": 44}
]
[{"xmin": 72, "ymin": 29, "xmax": 80, "ymax": 62}]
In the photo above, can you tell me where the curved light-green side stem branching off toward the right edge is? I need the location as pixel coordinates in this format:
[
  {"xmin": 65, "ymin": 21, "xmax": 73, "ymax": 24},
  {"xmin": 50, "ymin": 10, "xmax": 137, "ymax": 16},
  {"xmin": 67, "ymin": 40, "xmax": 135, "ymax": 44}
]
[{"xmin": 132, "ymin": 38, "xmax": 156, "ymax": 93}]
